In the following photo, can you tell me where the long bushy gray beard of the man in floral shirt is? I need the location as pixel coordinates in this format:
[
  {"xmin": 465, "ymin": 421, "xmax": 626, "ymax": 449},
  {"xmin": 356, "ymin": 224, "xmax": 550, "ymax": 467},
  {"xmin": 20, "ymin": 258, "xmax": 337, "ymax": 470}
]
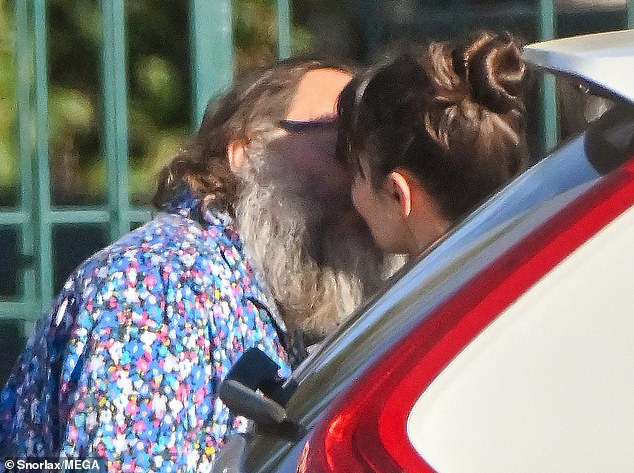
[{"xmin": 235, "ymin": 149, "xmax": 403, "ymax": 338}]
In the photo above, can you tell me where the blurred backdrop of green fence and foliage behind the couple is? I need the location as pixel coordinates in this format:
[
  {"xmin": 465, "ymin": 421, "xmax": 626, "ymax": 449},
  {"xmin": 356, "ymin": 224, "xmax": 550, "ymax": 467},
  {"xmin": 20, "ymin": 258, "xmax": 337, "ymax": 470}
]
[{"xmin": 0, "ymin": 0, "xmax": 632, "ymax": 382}]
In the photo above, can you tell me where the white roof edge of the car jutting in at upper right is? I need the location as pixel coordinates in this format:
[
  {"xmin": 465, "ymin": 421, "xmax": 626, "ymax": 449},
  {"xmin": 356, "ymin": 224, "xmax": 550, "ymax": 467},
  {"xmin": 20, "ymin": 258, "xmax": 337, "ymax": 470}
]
[{"xmin": 523, "ymin": 30, "xmax": 634, "ymax": 103}]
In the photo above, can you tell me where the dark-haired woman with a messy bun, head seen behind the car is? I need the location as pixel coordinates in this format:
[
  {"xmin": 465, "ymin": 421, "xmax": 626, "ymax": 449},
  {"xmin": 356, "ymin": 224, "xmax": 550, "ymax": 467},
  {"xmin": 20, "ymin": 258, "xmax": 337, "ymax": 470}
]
[{"xmin": 338, "ymin": 33, "xmax": 529, "ymax": 254}]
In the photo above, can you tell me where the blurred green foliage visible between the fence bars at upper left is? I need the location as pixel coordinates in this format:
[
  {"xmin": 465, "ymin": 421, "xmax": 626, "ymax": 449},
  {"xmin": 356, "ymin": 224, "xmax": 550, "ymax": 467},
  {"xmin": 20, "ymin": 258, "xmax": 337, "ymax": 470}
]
[{"xmin": 0, "ymin": 0, "xmax": 311, "ymax": 205}]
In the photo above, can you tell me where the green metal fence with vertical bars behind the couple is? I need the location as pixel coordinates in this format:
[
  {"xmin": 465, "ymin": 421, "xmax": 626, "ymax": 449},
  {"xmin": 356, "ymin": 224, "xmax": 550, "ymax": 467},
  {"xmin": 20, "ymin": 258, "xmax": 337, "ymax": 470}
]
[{"xmin": 0, "ymin": 0, "xmax": 634, "ymax": 342}]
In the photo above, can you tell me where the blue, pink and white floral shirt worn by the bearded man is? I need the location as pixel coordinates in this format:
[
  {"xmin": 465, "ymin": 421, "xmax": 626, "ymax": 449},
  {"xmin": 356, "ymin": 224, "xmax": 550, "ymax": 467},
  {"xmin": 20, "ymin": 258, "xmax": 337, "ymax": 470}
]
[{"xmin": 0, "ymin": 193, "xmax": 289, "ymax": 472}]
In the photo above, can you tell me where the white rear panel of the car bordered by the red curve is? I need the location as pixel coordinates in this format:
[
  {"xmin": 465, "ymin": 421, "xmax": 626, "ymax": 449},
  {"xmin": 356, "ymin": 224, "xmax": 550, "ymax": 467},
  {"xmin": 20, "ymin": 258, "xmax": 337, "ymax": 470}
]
[{"xmin": 407, "ymin": 208, "xmax": 634, "ymax": 473}]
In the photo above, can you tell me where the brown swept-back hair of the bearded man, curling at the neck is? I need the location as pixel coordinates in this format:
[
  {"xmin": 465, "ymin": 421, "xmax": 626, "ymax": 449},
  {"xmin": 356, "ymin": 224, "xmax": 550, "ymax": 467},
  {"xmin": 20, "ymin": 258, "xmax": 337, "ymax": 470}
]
[{"xmin": 152, "ymin": 58, "xmax": 353, "ymax": 214}]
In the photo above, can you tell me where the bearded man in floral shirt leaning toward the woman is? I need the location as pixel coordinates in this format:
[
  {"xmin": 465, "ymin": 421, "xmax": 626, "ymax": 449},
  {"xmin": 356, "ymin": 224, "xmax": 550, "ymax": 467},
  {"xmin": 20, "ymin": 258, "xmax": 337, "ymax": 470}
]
[{"xmin": 0, "ymin": 61, "xmax": 396, "ymax": 471}]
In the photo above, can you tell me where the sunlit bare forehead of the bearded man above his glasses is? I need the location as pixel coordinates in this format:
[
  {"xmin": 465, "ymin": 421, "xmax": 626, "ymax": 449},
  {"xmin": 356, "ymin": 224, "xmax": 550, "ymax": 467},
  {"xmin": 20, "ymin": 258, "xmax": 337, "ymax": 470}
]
[{"xmin": 286, "ymin": 69, "xmax": 352, "ymax": 121}]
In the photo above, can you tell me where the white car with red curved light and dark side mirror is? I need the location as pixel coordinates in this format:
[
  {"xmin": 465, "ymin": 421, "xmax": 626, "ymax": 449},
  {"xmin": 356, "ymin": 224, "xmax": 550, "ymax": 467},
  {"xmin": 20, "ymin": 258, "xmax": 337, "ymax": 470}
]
[{"xmin": 216, "ymin": 30, "xmax": 634, "ymax": 473}]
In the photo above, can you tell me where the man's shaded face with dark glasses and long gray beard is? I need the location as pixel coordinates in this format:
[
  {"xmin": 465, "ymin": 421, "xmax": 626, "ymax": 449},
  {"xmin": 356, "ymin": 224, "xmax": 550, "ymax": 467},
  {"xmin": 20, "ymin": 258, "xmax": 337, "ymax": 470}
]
[{"xmin": 236, "ymin": 111, "xmax": 390, "ymax": 351}]
